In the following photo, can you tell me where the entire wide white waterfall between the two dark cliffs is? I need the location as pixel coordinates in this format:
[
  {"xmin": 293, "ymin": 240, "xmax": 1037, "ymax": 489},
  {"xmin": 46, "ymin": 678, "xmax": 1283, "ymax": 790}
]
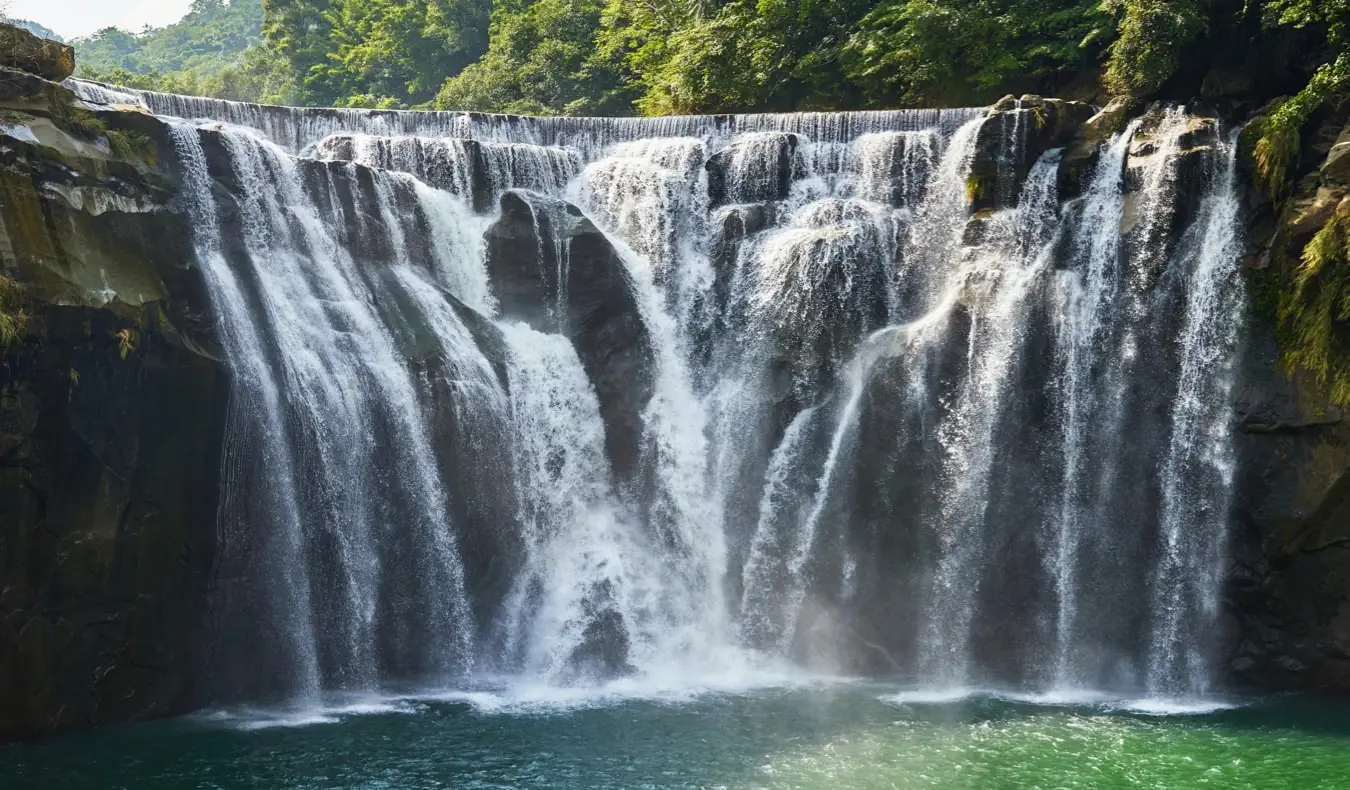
[{"xmin": 102, "ymin": 82, "xmax": 1243, "ymax": 704}]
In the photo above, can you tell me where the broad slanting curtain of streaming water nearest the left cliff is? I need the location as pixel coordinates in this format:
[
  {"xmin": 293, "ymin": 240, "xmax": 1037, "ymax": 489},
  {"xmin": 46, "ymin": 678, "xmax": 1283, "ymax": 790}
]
[{"xmin": 166, "ymin": 120, "xmax": 486, "ymax": 694}]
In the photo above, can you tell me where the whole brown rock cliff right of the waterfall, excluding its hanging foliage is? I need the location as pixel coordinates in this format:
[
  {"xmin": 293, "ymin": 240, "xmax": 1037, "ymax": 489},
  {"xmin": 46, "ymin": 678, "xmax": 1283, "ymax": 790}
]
[{"xmin": 1229, "ymin": 108, "xmax": 1350, "ymax": 693}]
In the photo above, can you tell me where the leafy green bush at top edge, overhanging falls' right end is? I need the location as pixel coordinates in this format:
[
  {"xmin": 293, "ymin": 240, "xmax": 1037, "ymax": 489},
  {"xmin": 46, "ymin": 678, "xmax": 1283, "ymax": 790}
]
[{"xmin": 1103, "ymin": 0, "xmax": 1208, "ymax": 99}]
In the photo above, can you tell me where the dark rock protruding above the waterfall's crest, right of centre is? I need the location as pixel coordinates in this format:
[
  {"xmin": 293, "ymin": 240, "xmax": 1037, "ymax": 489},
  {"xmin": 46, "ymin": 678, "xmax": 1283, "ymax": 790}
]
[{"xmin": 967, "ymin": 96, "xmax": 1092, "ymax": 211}]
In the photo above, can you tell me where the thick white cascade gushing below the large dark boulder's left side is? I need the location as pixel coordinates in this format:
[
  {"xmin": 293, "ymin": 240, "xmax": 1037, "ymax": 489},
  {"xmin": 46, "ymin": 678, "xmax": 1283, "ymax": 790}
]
[{"xmin": 504, "ymin": 324, "xmax": 648, "ymax": 679}]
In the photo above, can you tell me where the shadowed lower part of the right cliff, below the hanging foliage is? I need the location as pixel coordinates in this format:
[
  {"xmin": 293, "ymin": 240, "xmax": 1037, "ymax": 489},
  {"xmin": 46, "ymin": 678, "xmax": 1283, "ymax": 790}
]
[{"xmin": 1226, "ymin": 328, "xmax": 1350, "ymax": 691}]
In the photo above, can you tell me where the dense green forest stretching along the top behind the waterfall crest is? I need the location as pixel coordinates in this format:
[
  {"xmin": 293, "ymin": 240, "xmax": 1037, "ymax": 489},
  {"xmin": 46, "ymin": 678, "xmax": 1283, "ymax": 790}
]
[{"xmin": 68, "ymin": 0, "xmax": 1350, "ymax": 115}]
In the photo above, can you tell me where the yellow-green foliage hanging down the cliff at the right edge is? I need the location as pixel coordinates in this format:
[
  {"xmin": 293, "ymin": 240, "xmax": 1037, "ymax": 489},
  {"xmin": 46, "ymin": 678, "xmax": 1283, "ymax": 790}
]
[{"xmin": 1280, "ymin": 212, "xmax": 1350, "ymax": 406}]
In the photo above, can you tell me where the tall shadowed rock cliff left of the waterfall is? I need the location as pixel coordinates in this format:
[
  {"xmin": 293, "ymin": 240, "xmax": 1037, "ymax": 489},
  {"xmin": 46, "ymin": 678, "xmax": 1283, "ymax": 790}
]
[{"xmin": 0, "ymin": 30, "xmax": 227, "ymax": 741}]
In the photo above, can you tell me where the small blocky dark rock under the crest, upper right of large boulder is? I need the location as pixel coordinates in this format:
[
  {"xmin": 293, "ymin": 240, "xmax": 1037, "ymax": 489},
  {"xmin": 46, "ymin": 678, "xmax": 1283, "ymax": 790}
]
[{"xmin": 705, "ymin": 132, "xmax": 798, "ymax": 208}]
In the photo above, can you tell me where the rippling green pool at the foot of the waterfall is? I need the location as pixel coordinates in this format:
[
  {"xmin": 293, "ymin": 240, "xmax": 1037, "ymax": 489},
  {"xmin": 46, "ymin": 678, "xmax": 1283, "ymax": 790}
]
[{"xmin": 0, "ymin": 685, "xmax": 1350, "ymax": 790}]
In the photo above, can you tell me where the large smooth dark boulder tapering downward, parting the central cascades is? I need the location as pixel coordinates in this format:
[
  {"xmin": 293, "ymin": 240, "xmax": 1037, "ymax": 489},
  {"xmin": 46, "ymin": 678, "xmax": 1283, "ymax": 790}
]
[{"xmin": 486, "ymin": 190, "xmax": 653, "ymax": 481}]
